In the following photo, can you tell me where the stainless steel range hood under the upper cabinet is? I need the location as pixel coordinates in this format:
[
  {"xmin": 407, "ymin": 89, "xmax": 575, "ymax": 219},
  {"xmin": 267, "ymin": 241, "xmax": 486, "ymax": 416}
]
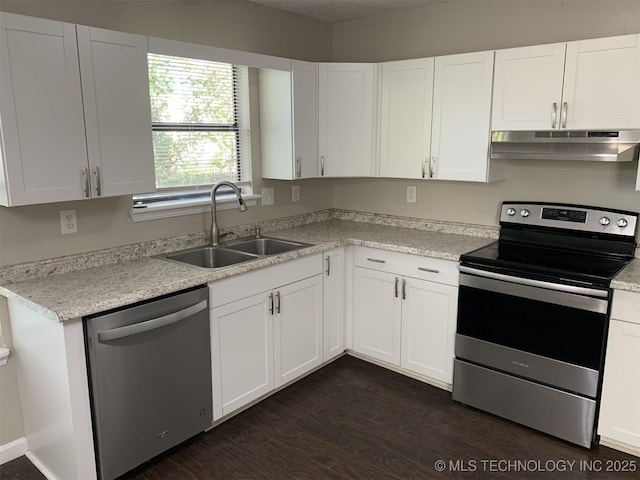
[{"xmin": 491, "ymin": 130, "xmax": 640, "ymax": 162}]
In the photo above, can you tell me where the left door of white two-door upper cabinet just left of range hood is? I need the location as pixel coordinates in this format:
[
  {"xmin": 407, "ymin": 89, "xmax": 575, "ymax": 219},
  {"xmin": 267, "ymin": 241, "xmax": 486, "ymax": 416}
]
[{"xmin": 380, "ymin": 58, "xmax": 433, "ymax": 178}]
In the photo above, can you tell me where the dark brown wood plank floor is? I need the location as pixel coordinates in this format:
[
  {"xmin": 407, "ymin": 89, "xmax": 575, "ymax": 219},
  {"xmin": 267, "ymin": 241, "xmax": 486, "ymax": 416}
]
[{"xmin": 0, "ymin": 356, "xmax": 640, "ymax": 480}]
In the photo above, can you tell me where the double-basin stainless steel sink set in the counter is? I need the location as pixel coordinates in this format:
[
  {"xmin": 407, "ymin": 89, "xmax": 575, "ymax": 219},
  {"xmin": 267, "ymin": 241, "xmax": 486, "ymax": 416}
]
[{"xmin": 162, "ymin": 237, "xmax": 309, "ymax": 269}]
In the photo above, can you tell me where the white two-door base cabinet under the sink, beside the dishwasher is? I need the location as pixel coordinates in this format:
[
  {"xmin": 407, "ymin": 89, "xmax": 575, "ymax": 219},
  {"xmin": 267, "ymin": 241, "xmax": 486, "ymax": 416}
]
[{"xmin": 209, "ymin": 255, "xmax": 323, "ymax": 420}]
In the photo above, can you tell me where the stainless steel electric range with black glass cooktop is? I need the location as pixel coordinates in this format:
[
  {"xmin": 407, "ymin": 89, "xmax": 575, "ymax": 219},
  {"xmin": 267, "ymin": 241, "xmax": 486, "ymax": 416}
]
[{"xmin": 453, "ymin": 202, "xmax": 638, "ymax": 447}]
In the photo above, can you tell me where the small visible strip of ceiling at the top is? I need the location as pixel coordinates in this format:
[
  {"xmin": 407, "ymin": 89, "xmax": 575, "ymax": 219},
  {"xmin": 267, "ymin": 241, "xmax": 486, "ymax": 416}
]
[{"xmin": 249, "ymin": 0, "xmax": 449, "ymax": 23}]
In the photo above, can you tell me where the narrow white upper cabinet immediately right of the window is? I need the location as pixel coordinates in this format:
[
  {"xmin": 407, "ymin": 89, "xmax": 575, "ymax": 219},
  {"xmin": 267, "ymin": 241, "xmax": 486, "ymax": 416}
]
[{"xmin": 259, "ymin": 60, "xmax": 320, "ymax": 180}]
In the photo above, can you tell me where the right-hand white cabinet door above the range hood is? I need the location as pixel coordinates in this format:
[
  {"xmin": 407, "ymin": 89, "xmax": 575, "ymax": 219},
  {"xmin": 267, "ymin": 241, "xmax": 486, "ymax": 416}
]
[{"xmin": 562, "ymin": 35, "xmax": 640, "ymax": 129}]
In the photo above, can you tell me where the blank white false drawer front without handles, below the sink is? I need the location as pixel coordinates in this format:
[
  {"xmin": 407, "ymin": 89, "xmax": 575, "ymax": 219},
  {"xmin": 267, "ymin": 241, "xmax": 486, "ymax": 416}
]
[{"xmin": 209, "ymin": 254, "xmax": 322, "ymax": 308}]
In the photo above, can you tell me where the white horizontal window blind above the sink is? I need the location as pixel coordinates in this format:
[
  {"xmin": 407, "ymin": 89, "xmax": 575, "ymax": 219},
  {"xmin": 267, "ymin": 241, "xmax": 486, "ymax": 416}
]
[{"xmin": 148, "ymin": 53, "xmax": 251, "ymax": 190}]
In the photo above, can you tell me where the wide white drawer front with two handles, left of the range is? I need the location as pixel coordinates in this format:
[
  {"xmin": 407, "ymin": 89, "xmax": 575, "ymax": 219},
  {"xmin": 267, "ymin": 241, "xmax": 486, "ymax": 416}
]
[{"xmin": 354, "ymin": 247, "xmax": 459, "ymax": 286}]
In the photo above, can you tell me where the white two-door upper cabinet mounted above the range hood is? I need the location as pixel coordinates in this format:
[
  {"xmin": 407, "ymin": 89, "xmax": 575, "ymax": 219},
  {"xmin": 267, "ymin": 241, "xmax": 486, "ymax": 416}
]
[{"xmin": 491, "ymin": 35, "xmax": 640, "ymax": 130}]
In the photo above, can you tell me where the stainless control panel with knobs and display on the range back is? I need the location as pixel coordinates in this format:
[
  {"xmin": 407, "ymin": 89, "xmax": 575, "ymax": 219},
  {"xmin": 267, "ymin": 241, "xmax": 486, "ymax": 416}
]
[{"xmin": 500, "ymin": 202, "xmax": 638, "ymax": 237}]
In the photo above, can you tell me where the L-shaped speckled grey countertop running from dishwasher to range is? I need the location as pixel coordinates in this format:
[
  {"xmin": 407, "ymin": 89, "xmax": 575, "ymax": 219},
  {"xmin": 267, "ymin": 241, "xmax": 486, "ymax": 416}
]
[{"xmin": 0, "ymin": 219, "xmax": 492, "ymax": 322}]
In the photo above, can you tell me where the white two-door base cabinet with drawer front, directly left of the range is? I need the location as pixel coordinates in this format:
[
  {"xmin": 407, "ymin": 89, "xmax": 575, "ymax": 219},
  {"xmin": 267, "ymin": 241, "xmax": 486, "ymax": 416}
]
[{"xmin": 353, "ymin": 247, "xmax": 458, "ymax": 384}]
